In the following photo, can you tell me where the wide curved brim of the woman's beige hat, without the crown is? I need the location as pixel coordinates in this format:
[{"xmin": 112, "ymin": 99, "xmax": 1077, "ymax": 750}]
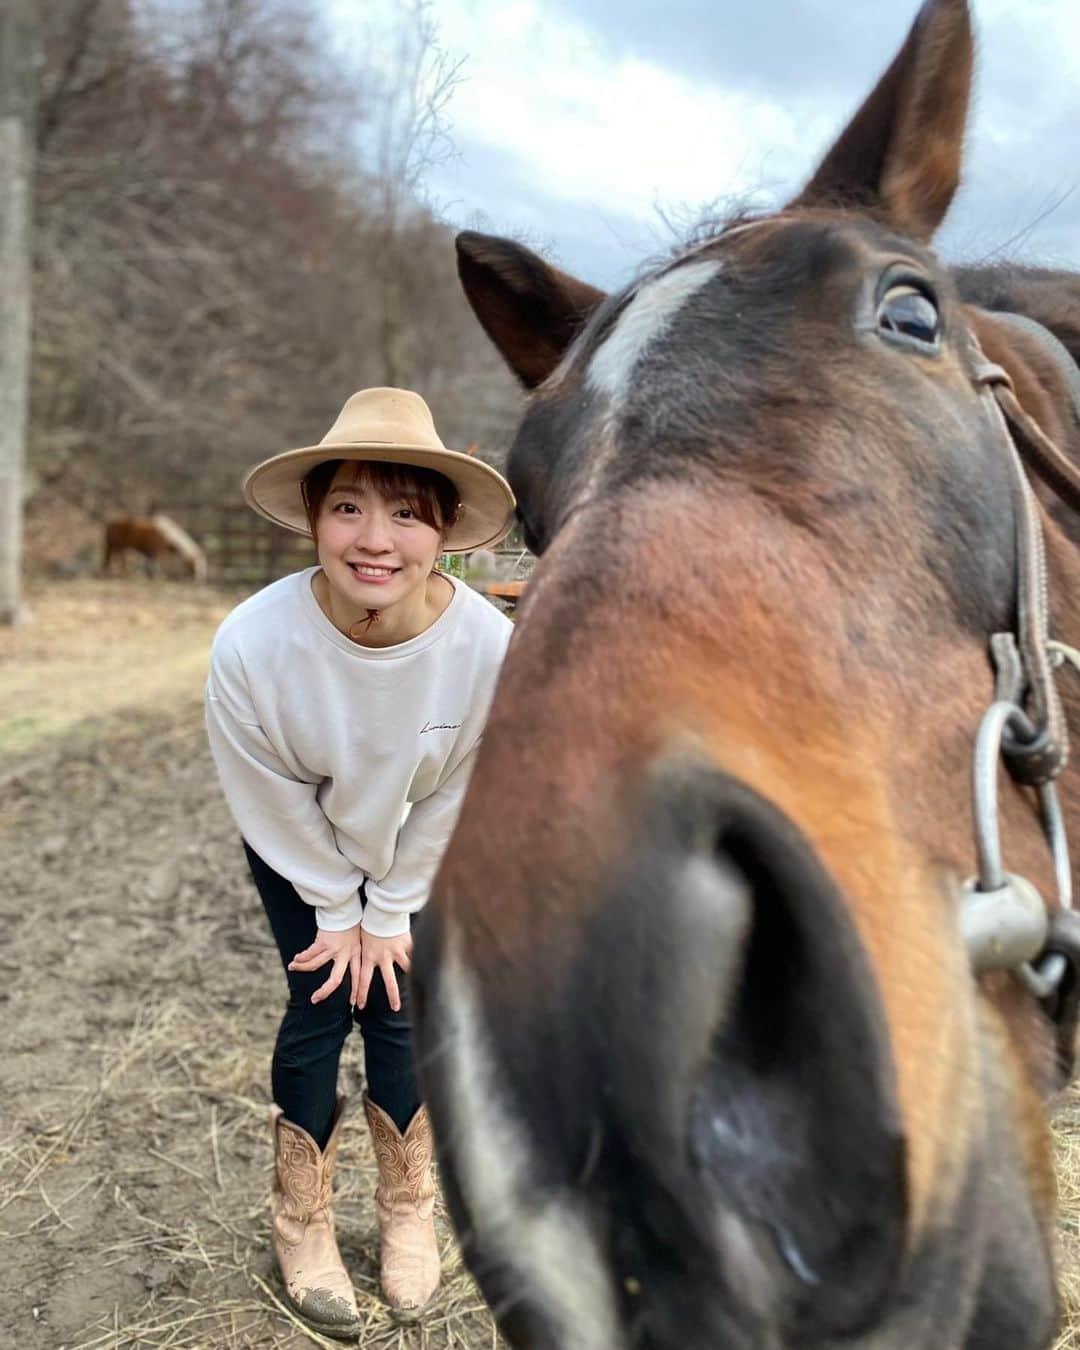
[{"xmin": 243, "ymin": 441, "xmax": 514, "ymax": 554}]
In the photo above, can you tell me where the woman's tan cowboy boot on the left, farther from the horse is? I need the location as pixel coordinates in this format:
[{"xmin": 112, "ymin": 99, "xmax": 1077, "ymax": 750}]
[{"xmin": 270, "ymin": 1098, "xmax": 360, "ymax": 1339}]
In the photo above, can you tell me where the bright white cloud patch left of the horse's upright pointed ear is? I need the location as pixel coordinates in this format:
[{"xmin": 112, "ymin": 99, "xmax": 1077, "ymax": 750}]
[{"xmin": 440, "ymin": 0, "xmax": 829, "ymax": 224}]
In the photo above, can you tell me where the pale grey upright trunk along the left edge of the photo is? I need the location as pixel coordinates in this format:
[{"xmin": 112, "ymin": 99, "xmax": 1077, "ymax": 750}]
[{"xmin": 0, "ymin": 0, "xmax": 38, "ymax": 624}]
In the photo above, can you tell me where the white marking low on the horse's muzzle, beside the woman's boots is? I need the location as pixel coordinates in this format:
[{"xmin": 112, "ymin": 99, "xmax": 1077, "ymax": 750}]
[{"xmin": 436, "ymin": 929, "xmax": 621, "ymax": 1350}]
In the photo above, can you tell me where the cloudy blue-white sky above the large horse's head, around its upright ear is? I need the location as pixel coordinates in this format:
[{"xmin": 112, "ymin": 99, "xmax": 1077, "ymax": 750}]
[{"xmin": 327, "ymin": 0, "xmax": 1080, "ymax": 294}]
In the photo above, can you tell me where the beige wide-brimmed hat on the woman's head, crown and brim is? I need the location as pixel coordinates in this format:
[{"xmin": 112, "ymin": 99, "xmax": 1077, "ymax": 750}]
[{"xmin": 243, "ymin": 389, "xmax": 514, "ymax": 554}]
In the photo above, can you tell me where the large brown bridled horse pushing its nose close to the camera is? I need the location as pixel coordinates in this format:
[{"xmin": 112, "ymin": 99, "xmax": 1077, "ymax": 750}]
[{"xmin": 413, "ymin": 0, "xmax": 1080, "ymax": 1350}]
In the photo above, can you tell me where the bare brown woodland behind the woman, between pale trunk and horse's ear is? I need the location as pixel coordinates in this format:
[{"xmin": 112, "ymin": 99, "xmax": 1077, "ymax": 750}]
[{"xmin": 24, "ymin": 0, "xmax": 520, "ymax": 558}]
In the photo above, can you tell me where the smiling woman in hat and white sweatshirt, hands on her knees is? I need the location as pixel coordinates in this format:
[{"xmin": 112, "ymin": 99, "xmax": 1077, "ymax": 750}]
[{"xmin": 207, "ymin": 389, "xmax": 514, "ymax": 1337}]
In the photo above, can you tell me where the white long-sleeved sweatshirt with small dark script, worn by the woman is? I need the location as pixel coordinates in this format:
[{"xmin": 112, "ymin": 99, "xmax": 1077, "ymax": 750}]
[{"xmin": 207, "ymin": 567, "xmax": 513, "ymax": 937}]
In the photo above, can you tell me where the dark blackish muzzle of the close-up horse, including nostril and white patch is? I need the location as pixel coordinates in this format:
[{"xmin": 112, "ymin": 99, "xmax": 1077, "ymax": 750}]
[{"xmin": 414, "ymin": 760, "xmax": 906, "ymax": 1350}]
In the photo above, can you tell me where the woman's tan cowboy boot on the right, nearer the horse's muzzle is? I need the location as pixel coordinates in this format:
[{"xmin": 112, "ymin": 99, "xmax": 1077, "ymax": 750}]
[{"xmin": 363, "ymin": 1096, "xmax": 439, "ymax": 1318}]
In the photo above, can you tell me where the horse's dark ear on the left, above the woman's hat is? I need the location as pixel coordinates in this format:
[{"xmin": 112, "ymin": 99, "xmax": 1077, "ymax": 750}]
[{"xmin": 458, "ymin": 231, "xmax": 605, "ymax": 389}]
